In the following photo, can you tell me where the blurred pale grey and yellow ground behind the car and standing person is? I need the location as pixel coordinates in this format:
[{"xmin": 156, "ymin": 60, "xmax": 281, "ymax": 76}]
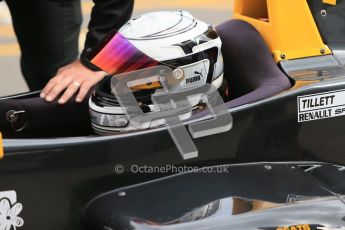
[{"xmin": 0, "ymin": 0, "xmax": 233, "ymax": 96}]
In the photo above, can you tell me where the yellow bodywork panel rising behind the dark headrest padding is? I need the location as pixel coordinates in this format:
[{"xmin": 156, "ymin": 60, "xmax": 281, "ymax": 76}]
[{"xmin": 234, "ymin": 0, "xmax": 331, "ymax": 62}]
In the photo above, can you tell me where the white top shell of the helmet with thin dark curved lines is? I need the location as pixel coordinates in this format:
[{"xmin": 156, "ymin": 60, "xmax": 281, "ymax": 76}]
[{"xmin": 119, "ymin": 11, "xmax": 221, "ymax": 61}]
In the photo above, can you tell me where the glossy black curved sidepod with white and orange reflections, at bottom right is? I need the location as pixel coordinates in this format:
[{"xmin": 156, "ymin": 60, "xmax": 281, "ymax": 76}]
[{"xmin": 84, "ymin": 163, "xmax": 345, "ymax": 230}]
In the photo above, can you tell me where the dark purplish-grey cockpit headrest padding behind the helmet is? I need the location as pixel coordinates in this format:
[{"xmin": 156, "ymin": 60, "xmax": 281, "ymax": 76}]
[{"xmin": 216, "ymin": 20, "xmax": 291, "ymax": 108}]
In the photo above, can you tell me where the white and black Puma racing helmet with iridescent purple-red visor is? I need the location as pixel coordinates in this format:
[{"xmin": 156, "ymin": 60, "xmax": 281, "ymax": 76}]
[{"xmin": 89, "ymin": 11, "xmax": 227, "ymax": 134}]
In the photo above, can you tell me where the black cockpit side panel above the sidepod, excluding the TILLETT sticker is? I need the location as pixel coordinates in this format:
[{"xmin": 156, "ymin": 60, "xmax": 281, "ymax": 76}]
[{"xmin": 0, "ymin": 77, "xmax": 345, "ymax": 230}]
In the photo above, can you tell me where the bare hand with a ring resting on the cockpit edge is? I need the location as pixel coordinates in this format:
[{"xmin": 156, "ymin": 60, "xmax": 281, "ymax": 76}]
[{"xmin": 40, "ymin": 60, "xmax": 105, "ymax": 104}]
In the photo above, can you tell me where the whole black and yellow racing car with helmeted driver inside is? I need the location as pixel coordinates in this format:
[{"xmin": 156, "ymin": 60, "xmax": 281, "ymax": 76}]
[{"xmin": 0, "ymin": 0, "xmax": 345, "ymax": 230}]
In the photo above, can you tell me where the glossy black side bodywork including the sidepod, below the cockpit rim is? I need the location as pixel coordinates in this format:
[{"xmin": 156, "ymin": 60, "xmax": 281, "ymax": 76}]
[{"xmin": 0, "ymin": 10, "xmax": 345, "ymax": 230}]
